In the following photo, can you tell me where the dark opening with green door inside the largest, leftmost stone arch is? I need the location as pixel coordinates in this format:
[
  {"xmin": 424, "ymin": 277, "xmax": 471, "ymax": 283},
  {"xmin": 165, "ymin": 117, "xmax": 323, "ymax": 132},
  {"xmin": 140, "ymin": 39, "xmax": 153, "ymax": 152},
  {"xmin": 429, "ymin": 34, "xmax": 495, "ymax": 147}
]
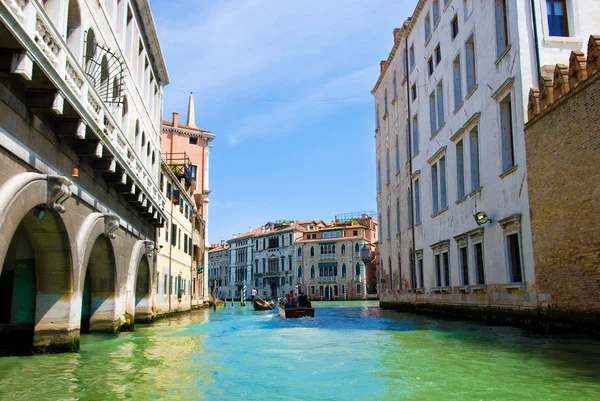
[{"xmin": 0, "ymin": 206, "xmax": 74, "ymax": 355}]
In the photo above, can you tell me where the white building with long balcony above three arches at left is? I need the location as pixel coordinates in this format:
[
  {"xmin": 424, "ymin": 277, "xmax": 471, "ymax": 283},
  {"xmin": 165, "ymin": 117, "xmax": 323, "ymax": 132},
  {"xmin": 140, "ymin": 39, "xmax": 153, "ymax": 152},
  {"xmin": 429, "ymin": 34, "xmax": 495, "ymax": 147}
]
[{"xmin": 0, "ymin": 0, "xmax": 169, "ymax": 354}]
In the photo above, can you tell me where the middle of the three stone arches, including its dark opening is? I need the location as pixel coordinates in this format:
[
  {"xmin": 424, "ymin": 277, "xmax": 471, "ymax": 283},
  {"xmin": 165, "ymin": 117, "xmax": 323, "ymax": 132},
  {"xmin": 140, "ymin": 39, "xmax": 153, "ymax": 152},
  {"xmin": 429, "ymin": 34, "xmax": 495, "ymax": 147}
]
[{"xmin": 75, "ymin": 213, "xmax": 120, "ymax": 332}]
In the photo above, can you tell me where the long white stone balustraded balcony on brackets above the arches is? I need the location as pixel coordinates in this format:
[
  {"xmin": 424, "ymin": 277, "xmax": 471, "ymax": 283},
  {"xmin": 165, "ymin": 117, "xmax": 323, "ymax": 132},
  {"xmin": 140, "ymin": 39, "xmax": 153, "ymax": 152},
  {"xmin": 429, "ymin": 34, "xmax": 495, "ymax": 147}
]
[{"xmin": 0, "ymin": 0, "xmax": 166, "ymax": 227}]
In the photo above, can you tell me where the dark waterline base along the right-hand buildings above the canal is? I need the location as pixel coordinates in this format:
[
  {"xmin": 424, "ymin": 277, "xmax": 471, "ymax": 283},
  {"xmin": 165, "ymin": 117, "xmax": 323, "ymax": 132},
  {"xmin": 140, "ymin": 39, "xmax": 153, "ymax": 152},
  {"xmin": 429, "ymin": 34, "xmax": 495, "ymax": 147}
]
[{"xmin": 379, "ymin": 301, "xmax": 600, "ymax": 336}]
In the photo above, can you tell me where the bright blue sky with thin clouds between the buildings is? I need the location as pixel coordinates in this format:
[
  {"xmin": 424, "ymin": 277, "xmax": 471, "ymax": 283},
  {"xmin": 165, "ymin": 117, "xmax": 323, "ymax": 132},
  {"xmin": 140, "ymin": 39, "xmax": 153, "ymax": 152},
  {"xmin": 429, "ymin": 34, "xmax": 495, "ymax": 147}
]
[{"xmin": 150, "ymin": 0, "xmax": 416, "ymax": 243}]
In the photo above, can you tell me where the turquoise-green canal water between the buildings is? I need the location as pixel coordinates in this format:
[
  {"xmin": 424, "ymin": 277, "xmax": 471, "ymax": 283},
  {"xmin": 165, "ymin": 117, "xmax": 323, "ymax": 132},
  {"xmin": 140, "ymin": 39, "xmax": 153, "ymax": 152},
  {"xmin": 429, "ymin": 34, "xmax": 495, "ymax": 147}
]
[{"xmin": 0, "ymin": 302, "xmax": 600, "ymax": 401}]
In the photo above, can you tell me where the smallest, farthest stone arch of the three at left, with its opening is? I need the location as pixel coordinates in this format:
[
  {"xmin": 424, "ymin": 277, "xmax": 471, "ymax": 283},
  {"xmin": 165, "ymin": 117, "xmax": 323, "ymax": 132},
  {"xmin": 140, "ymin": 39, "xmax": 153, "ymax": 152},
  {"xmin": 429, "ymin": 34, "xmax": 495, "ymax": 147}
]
[{"xmin": 125, "ymin": 240, "xmax": 154, "ymax": 321}]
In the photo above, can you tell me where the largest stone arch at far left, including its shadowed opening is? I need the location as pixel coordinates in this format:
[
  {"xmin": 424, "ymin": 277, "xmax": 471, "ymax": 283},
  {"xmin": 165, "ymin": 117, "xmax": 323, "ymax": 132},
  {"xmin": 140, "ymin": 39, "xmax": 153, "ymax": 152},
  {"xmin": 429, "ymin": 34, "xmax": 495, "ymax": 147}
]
[{"xmin": 0, "ymin": 173, "xmax": 79, "ymax": 354}]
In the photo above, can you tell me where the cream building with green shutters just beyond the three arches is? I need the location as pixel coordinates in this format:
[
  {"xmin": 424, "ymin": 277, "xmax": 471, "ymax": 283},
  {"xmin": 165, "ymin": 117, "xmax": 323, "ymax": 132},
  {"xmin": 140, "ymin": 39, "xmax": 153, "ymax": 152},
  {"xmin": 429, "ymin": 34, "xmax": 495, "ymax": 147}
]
[{"xmin": 153, "ymin": 160, "xmax": 202, "ymax": 314}]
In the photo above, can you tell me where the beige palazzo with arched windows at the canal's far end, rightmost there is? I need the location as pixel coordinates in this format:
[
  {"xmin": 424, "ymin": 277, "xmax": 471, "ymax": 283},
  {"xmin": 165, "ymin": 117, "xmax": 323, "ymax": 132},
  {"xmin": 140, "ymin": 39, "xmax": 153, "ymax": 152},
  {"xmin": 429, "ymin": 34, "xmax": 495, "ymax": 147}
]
[{"xmin": 296, "ymin": 213, "xmax": 377, "ymax": 300}]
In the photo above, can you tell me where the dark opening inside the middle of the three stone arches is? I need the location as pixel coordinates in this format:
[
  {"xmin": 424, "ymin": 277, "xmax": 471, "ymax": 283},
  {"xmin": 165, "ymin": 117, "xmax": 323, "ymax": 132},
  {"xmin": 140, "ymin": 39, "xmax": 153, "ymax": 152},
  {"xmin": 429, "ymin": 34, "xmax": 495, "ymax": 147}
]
[{"xmin": 80, "ymin": 235, "xmax": 116, "ymax": 333}]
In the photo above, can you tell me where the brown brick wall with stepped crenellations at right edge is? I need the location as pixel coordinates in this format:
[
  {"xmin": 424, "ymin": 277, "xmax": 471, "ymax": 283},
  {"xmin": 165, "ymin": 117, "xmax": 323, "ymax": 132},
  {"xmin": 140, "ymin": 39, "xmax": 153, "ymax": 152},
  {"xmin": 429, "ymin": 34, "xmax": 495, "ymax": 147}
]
[{"xmin": 525, "ymin": 36, "xmax": 600, "ymax": 331}]
